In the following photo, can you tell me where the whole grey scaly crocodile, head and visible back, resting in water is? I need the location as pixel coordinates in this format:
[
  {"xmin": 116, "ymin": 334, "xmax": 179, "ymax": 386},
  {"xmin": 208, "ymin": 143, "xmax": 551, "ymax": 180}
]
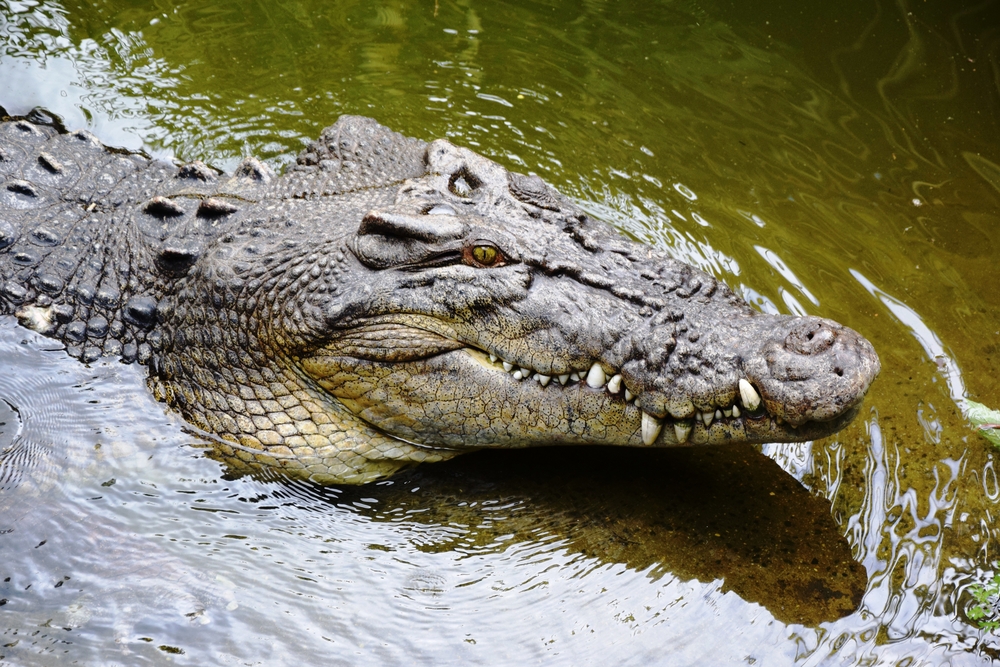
[{"xmin": 0, "ymin": 116, "xmax": 879, "ymax": 482}]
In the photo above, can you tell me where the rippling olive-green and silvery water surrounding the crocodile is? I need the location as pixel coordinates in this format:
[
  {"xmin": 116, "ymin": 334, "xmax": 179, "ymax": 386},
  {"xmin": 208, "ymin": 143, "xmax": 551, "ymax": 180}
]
[{"xmin": 0, "ymin": 0, "xmax": 1000, "ymax": 665}]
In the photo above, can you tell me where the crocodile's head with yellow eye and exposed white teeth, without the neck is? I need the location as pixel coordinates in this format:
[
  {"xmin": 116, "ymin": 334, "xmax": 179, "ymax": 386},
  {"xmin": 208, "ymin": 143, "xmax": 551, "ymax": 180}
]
[{"xmin": 298, "ymin": 140, "xmax": 879, "ymax": 456}]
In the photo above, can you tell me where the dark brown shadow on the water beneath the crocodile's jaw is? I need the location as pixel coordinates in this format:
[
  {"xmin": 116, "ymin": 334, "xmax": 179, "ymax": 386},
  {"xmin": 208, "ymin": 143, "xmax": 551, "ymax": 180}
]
[{"xmin": 274, "ymin": 446, "xmax": 867, "ymax": 626}]
